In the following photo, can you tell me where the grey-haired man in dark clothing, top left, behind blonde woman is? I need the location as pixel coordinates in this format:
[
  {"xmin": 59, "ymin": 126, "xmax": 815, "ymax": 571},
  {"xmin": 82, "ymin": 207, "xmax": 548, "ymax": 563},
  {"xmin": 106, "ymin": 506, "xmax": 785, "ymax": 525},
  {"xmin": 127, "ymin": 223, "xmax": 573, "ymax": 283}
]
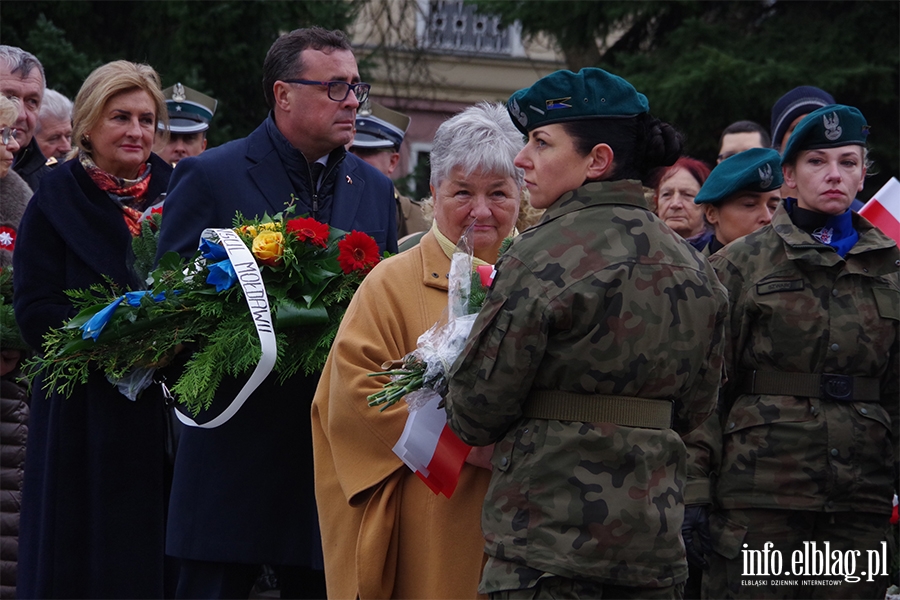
[{"xmin": 0, "ymin": 45, "xmax": 55, "ymax": 192}]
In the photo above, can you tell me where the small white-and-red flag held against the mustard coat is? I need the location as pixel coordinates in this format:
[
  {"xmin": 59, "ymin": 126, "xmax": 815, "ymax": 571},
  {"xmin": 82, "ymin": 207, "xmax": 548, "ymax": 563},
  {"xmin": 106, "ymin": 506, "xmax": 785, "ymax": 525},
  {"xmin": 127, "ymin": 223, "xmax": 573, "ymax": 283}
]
[{"xmin": 394, "ymin": 394, "xmax": 472, "ymax": 498}]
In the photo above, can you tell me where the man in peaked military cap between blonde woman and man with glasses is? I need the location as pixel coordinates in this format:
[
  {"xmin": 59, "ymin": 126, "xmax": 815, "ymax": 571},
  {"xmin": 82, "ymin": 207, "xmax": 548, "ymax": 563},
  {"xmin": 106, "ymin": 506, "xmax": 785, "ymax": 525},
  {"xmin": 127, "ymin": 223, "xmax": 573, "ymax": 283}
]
[{"xmin": 153, "ymin": 83, "xmax": 218, "ymax": 167}]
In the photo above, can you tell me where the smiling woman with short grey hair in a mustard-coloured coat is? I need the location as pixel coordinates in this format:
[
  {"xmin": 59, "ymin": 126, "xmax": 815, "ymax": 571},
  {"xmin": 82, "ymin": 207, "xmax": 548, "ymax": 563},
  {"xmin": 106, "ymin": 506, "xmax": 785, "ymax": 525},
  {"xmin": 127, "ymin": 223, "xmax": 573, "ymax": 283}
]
[{"xmin": 312, "ymin": 104, "xmax": 522, "ymax": 598}]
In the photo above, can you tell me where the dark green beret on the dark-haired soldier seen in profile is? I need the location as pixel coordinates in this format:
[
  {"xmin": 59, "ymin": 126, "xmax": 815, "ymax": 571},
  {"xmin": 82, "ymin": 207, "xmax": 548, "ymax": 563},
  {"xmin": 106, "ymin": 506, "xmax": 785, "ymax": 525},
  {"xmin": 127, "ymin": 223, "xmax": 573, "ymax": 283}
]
[{"xmin": 506, "ymin": 67, "xmax": 650, "ymax": 134}]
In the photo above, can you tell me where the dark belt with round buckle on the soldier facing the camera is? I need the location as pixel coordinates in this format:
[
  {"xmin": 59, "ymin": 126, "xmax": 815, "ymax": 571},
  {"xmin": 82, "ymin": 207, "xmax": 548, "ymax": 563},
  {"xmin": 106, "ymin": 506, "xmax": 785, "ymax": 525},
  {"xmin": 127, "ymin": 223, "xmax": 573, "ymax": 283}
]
[{"xmin": 738, "ymin": 371, "xmax": 881, "ymax": 402}]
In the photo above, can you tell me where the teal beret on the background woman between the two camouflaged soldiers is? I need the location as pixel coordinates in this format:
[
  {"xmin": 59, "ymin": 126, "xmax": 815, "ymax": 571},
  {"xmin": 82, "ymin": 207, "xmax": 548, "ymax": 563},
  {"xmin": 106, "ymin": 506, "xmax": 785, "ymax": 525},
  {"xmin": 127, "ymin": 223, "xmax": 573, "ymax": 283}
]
[{"xmin": 694, "ymin": 148, "xmax": 784, "ymax": 204}]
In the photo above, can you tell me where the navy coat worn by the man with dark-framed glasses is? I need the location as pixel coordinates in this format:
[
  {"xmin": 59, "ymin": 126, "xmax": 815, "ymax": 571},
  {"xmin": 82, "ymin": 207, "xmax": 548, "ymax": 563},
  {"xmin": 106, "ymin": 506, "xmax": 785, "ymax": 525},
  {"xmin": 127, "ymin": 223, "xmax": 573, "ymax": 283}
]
[{"xmin": 159, "ymin": 117, "xmax": 397, "ymax": 569}]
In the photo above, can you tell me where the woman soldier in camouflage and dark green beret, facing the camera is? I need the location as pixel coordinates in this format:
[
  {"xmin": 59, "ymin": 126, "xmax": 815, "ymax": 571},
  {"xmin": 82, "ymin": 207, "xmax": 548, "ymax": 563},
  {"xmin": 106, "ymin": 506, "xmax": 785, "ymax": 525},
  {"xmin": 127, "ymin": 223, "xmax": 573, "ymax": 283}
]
[{"xmin": 703, "ymin": 105, "xmax": 900, "ymax": 598}]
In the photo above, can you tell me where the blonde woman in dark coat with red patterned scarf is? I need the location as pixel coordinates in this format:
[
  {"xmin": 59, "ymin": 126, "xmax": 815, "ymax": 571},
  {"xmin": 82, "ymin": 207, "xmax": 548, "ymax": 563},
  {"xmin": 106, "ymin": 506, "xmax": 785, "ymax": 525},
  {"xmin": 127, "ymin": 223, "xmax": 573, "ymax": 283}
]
[{"xmin": 13, "ymin": 61, "xmax": 172, "ymax": 598}]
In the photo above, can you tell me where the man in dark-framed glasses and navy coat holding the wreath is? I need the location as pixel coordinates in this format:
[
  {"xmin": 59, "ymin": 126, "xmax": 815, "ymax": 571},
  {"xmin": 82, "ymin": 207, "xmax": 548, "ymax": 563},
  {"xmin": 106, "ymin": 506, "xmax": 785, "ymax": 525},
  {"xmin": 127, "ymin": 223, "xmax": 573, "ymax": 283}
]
[{"xmin": 159, "ymin": 27, "xmax": 397, "ymax": 598}]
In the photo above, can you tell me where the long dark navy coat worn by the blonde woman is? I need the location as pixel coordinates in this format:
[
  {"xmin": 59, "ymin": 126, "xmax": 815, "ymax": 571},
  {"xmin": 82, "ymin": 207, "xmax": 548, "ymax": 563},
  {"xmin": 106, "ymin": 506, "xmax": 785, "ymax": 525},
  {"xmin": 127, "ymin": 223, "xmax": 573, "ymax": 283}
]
[{"xmin": 13, "ymin": 155, "xmax": 172, "ymax": 598}]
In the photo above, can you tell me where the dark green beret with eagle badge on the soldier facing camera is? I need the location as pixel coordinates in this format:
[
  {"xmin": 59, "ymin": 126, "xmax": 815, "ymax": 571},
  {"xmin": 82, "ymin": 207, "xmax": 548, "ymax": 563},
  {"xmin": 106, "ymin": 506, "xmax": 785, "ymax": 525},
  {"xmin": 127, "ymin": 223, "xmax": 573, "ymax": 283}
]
[{"xmin": 781, "ymin": 104, "xmax": 869, "ymax": 164}]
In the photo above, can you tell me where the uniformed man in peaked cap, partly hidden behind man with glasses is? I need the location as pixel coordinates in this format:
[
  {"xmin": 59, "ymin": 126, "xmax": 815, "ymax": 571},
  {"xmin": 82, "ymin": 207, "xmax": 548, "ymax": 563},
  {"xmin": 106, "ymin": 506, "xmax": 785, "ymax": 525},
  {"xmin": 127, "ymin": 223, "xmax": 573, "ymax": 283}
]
[{"xmin": 350, "ymin": 101, "xmax": 428, "ymax": 238}]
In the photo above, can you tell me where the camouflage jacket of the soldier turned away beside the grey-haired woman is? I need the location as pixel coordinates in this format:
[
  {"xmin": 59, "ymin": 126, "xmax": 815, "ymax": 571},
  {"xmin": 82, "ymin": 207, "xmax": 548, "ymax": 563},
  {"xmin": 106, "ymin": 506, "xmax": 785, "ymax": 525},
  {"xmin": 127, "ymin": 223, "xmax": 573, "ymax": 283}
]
[{"xmin": 447, "ymin": 181, "xmax": 727, "ymax": 592}]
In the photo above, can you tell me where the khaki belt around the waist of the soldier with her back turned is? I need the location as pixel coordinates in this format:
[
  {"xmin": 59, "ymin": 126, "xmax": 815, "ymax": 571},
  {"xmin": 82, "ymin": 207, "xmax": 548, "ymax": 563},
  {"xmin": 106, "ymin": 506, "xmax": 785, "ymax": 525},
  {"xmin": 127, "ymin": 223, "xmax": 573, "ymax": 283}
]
[{"xmin": 522, "ymin": 390, "xmax": 672, "ymax": 429}]
